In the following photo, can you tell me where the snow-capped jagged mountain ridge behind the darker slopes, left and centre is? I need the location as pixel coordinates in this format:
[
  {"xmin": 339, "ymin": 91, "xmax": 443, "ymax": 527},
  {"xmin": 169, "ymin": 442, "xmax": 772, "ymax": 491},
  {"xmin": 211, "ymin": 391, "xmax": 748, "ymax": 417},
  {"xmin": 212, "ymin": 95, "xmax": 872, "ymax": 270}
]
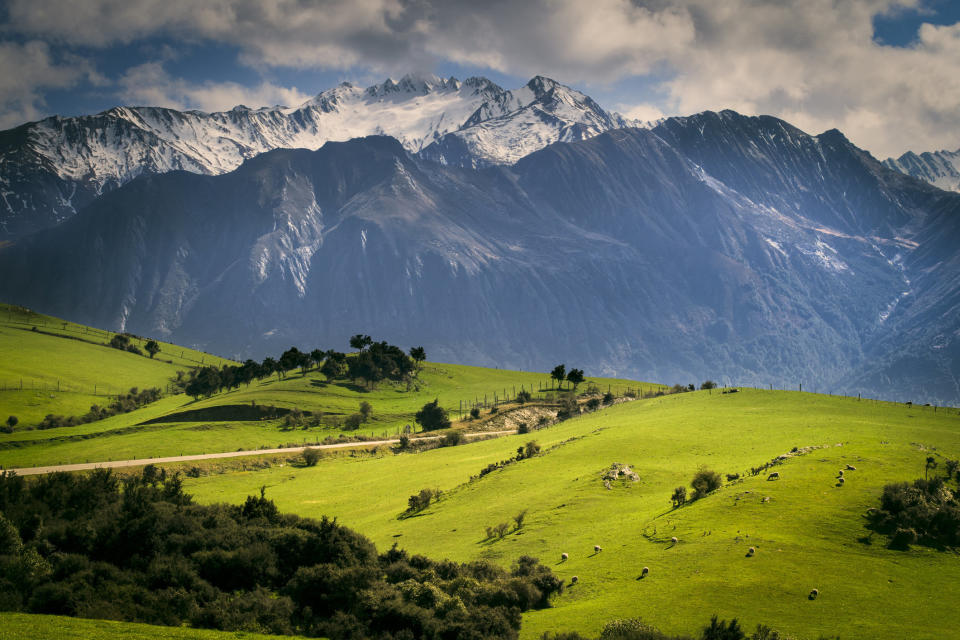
[{"xmin": 0, "ymin": 75, "xmax": 634, "ymax": 239}]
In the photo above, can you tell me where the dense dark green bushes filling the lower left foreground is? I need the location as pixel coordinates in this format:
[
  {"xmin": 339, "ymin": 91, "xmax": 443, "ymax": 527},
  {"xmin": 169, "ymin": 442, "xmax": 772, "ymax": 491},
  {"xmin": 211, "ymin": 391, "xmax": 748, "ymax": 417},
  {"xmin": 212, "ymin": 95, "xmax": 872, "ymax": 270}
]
[{"xmin": 0, "ymin": 467, "xmax": 562, "ymax": 639}]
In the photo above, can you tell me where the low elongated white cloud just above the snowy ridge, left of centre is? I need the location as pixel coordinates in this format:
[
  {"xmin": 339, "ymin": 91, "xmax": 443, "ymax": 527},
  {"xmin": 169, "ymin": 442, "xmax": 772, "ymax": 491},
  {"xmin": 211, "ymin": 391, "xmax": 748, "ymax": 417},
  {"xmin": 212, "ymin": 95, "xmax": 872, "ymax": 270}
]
[{"xmin": 119, "ymin": 62, "xmax": 310, "ymax": 111}]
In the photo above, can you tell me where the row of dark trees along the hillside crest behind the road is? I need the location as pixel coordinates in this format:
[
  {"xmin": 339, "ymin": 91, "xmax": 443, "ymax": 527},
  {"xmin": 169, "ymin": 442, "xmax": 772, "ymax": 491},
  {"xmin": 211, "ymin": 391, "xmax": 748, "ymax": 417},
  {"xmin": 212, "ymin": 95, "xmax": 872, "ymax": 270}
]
[{"xmin": 181, "ymin": 334, "xmax": 427, "ymax": 399}]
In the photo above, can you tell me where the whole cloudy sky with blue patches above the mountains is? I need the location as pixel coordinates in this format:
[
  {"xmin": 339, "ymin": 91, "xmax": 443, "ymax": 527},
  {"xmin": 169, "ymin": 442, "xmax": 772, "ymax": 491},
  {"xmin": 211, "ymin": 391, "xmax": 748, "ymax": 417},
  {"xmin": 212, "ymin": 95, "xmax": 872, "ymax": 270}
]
[{"xmin": 0, "ymin": 0, "xmax": 960, "ymax": 158}]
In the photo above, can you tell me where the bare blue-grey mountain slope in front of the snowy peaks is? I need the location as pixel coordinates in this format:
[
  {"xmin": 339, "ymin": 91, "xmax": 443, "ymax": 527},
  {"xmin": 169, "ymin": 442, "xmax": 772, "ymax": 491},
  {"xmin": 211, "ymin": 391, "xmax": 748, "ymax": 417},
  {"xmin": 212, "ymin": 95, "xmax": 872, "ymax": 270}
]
[{"xmin": 0, "ymin": 112, "xmax": 960, "ymax": 402}]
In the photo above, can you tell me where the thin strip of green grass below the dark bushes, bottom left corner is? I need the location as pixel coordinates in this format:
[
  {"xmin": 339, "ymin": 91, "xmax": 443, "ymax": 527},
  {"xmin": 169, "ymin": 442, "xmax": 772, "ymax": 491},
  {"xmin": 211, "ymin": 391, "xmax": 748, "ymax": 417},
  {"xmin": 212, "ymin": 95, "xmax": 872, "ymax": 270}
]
[{"xmin": 0, "ymin": 613, "xmax": 308, "ymax": 640}]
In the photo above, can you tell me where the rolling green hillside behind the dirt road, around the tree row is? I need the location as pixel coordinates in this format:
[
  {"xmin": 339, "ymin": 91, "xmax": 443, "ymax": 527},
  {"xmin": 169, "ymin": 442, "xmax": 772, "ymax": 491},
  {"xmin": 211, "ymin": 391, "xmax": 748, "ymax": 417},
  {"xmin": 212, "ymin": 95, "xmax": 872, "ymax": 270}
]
[{"xmin": 0, "ymin": 306, "xmax": 661, "ymax": 468}]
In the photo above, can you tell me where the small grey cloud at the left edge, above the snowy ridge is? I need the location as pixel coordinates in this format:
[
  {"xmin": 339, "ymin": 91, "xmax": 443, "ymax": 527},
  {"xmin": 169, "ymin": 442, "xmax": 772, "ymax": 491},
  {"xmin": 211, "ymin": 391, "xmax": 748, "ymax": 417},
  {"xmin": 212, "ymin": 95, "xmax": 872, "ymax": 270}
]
[{"xmin": 0, "ymin": 40, "xmax": 102, "ymax": 129}]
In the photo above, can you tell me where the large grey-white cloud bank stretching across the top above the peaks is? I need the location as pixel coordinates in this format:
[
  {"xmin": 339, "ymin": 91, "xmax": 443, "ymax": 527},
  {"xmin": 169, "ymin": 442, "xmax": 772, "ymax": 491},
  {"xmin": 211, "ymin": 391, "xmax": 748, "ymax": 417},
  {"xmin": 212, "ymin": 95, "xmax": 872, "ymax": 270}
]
[{"xmin": 7, "ymin": 0, "xmax": 960, "ymax": 155}]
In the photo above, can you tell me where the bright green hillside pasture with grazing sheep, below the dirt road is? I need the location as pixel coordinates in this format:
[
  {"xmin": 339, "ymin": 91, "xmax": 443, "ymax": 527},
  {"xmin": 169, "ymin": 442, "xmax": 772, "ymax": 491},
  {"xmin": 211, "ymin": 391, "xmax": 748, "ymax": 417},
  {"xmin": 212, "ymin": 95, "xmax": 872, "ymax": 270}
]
[{"xmin": 187, "ymin": 390, "xmax": 960, "ymax": 638}]
